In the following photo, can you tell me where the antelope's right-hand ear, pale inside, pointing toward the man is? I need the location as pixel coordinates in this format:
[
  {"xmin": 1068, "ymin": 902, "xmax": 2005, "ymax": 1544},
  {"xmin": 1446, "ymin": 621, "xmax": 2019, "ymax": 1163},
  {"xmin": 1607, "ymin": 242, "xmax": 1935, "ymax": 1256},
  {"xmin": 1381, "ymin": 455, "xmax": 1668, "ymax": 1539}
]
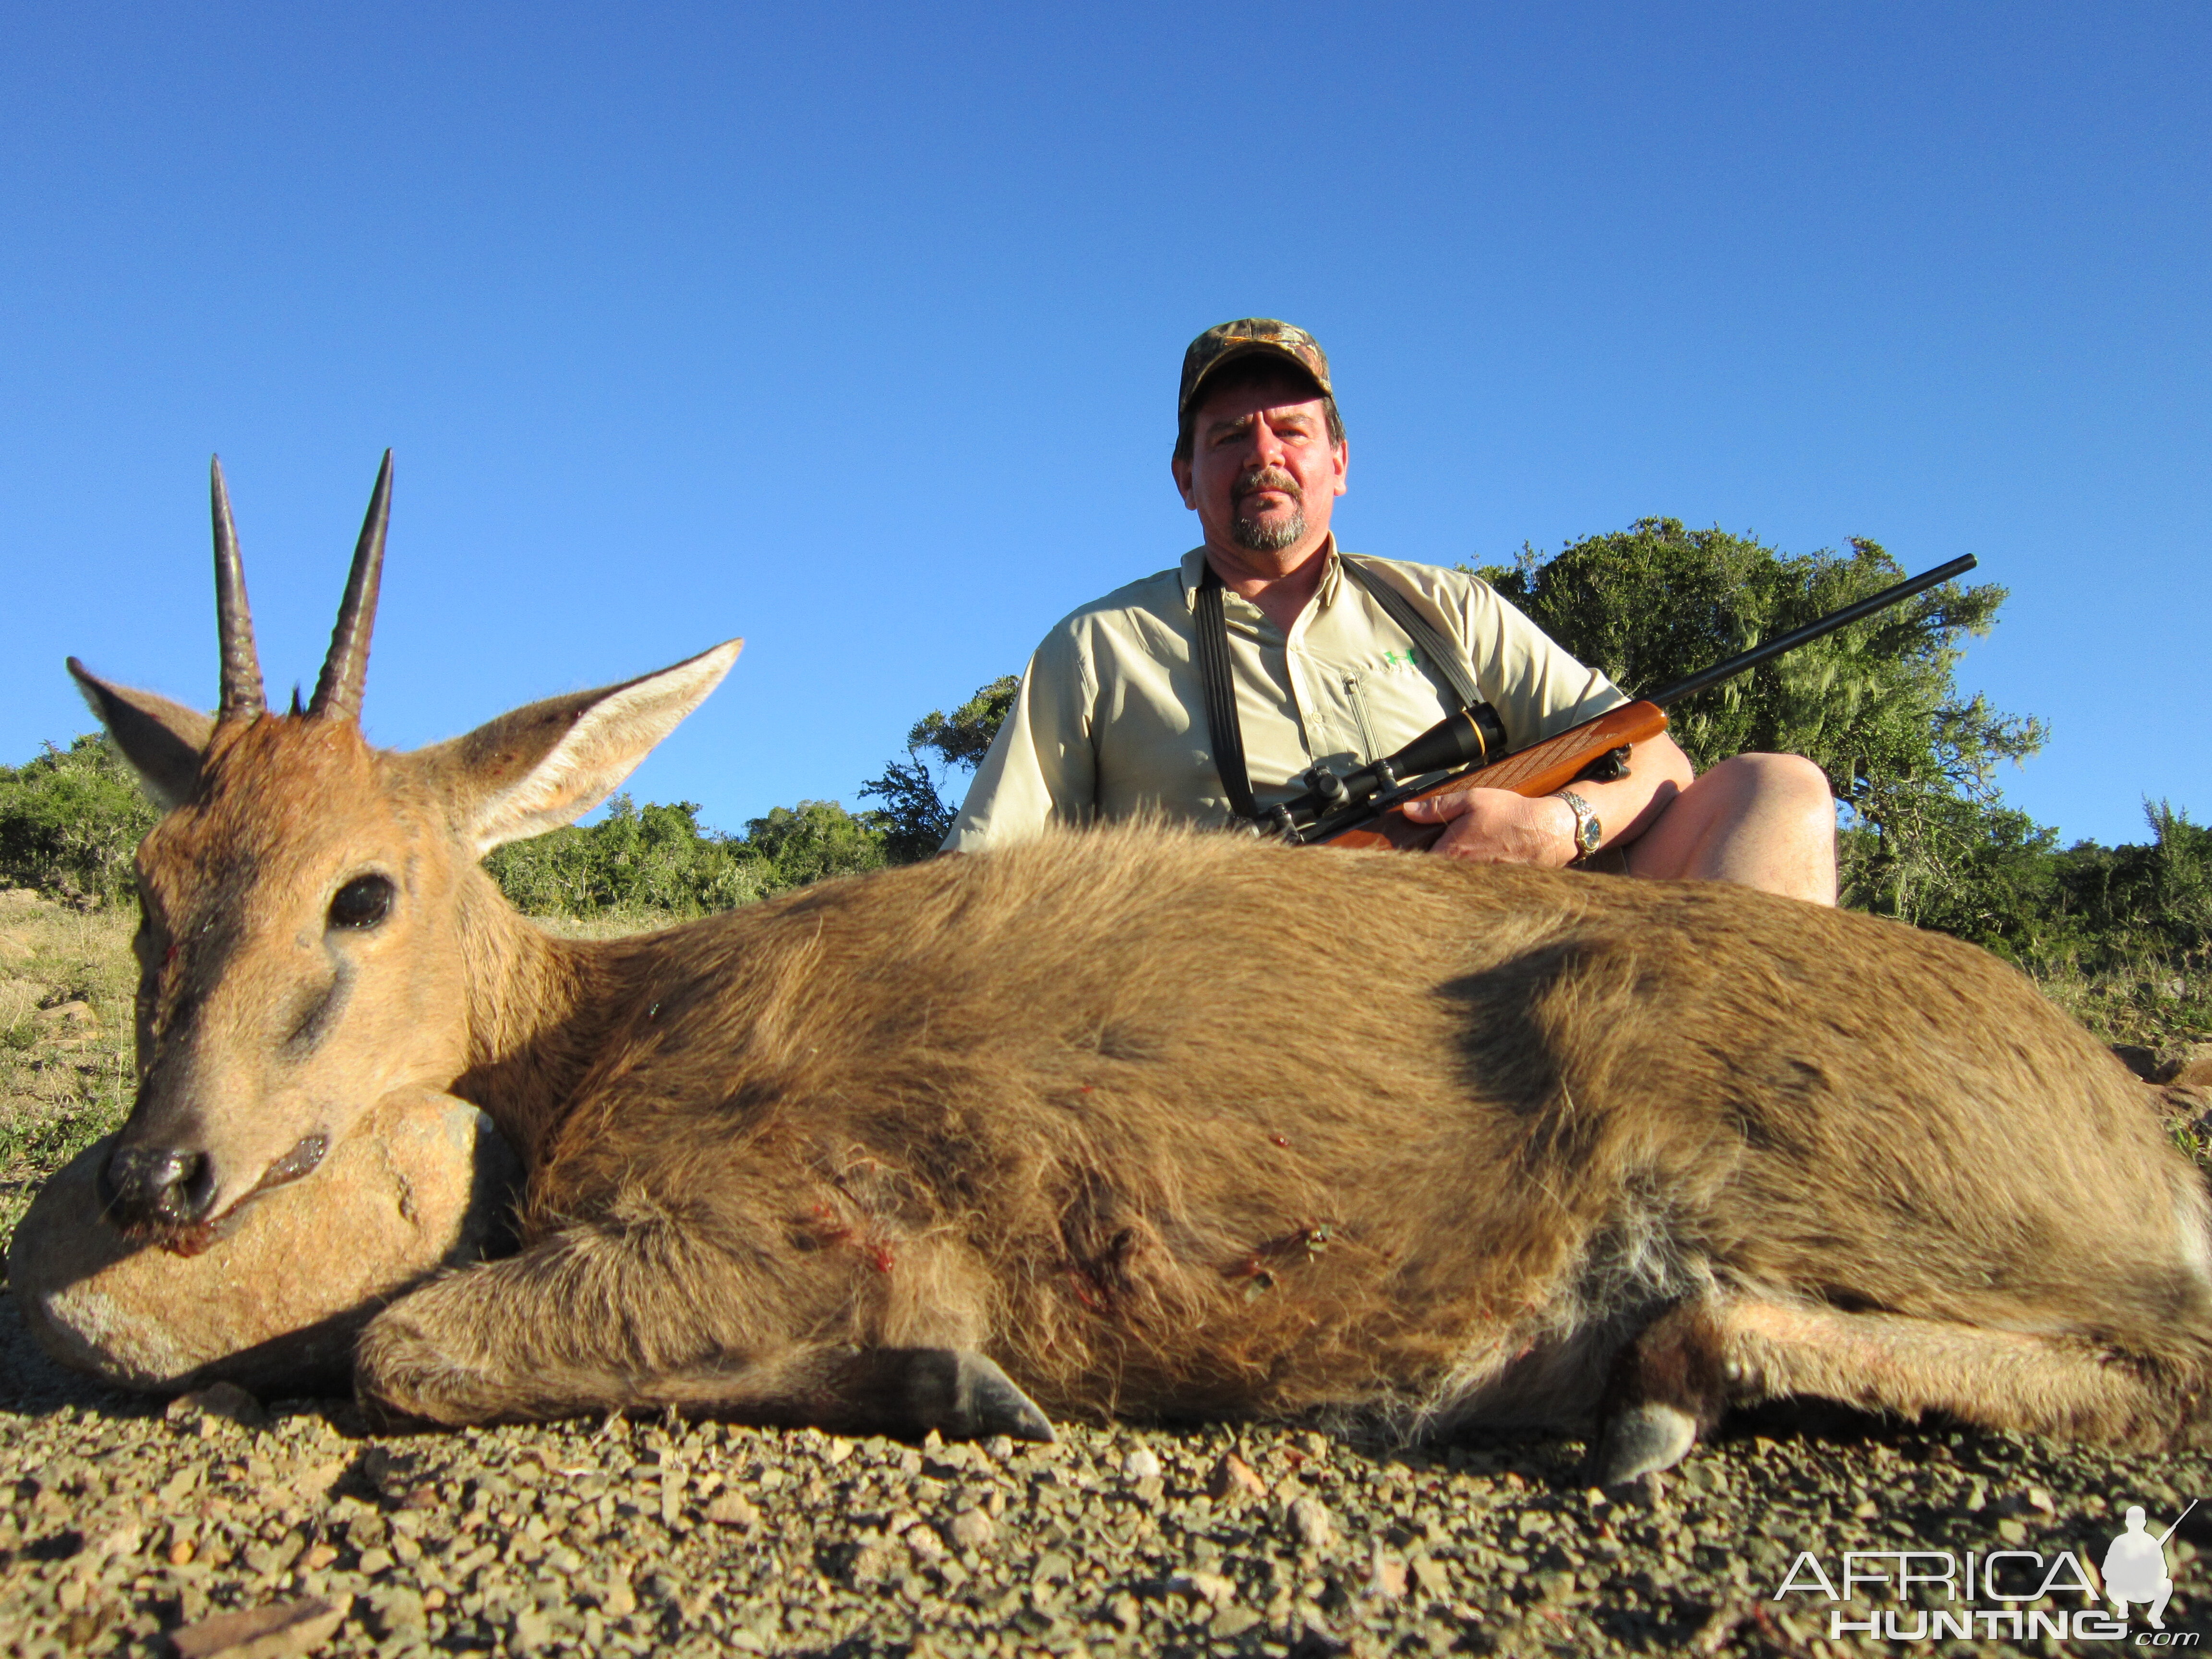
[{"xmin": 416, "ymin": 639, "xmax": 745, "ymax": 858}]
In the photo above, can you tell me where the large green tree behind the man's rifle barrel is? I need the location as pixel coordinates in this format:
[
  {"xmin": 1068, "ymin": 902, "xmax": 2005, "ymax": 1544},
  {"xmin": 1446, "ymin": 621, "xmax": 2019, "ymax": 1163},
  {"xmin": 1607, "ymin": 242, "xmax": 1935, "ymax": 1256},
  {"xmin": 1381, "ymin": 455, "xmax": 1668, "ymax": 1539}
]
[{"xmin": 1480, "ymin": 517, "xmax": 2046, "ymax": 923}]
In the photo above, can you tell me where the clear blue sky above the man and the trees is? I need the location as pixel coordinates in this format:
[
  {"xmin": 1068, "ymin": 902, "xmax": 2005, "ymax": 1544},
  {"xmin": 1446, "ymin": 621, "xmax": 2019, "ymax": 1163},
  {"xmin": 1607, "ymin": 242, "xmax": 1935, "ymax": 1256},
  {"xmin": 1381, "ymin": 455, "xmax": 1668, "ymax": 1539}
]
[{"xmin": 0, "ymin": 4, "xmax": 2212, "ymax": 841}]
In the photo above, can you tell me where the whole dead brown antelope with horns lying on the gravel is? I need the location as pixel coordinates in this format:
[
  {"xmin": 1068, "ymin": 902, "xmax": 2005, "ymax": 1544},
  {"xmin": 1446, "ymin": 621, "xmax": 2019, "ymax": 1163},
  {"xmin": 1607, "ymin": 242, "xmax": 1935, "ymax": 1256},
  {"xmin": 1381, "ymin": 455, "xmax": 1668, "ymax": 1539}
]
[{"xmin": 71, "ymin": 458, "xmax": 2212, "ymax": 1480}]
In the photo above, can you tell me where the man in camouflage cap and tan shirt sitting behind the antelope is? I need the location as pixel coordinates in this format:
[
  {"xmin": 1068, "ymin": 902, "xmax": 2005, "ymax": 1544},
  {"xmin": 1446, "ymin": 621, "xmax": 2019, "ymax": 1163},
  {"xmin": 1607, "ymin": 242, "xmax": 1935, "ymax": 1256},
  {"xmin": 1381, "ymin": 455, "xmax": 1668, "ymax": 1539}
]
[{"xmin": 945, "ymin": 316, "xmax": 1836, "ymax": 905}]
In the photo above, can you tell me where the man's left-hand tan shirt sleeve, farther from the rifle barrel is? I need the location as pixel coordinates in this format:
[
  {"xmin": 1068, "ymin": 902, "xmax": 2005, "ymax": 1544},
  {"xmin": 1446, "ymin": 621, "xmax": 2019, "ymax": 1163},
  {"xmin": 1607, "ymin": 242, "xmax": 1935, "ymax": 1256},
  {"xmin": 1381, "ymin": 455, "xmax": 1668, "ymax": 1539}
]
[{"xmin": 942, "ymin": 624, "xmax": 1097, "ymax": 852}]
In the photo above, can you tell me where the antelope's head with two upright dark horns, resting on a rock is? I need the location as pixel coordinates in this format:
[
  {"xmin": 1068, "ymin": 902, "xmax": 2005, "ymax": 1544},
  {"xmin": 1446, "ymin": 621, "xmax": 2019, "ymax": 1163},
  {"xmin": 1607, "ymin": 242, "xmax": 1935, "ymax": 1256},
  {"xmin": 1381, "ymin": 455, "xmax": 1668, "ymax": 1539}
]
[{"xmin": 69, "ymin": 451, "xmax": 743, "ymax": 1250}]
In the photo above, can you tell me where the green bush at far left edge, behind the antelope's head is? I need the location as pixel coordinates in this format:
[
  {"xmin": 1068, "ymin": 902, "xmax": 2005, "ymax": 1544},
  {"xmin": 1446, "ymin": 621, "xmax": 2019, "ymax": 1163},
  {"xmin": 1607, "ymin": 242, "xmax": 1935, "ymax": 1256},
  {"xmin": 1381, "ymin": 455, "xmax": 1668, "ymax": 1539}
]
[{"xmin": 0, "ymin": 732, "xmax": 161, "ymax": 902}]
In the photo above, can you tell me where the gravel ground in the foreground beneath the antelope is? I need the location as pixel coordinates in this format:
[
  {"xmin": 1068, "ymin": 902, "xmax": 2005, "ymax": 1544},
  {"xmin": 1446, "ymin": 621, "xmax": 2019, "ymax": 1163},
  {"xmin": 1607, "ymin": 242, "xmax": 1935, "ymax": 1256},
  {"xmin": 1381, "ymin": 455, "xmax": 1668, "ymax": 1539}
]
[{"xmin": 0, "ymin": 1296, "xmax": 2212, "ymax": 1659}]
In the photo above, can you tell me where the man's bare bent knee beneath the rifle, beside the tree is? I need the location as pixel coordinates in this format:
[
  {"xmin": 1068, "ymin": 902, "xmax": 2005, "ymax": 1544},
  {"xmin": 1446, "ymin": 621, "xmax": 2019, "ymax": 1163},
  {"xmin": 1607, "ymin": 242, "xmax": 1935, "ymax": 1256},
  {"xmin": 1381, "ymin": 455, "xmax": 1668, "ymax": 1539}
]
[{"xmin": 1628, "ymin": 754, "xmax": 1836, "ymax": 905}]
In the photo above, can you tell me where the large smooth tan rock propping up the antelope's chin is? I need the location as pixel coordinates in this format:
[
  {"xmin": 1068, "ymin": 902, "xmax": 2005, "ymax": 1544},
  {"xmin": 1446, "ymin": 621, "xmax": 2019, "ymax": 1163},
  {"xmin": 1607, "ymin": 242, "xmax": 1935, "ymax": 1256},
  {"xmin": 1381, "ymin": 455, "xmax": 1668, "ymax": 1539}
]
[{"xmin": 7, "ymin": 1091, "xmax": 522, "ymax": 1396}]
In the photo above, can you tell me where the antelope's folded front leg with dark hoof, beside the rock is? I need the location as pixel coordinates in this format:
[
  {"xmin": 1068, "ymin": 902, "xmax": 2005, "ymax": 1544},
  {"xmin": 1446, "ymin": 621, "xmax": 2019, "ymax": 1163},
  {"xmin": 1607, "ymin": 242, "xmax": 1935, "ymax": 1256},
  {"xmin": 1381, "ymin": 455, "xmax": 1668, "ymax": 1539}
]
[{"xmin": 354, "ymin": 1230, "xmax": 1053, "ymax": 1440}]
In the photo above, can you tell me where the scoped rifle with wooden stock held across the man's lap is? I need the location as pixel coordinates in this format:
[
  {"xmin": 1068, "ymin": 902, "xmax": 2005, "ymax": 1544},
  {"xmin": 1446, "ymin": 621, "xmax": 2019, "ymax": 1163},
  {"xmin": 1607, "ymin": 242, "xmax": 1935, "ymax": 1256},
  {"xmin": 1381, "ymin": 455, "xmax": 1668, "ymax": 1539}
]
[{"xmin": 1256, "ymin": 553, "xmax": 1978, "ymax": 852}]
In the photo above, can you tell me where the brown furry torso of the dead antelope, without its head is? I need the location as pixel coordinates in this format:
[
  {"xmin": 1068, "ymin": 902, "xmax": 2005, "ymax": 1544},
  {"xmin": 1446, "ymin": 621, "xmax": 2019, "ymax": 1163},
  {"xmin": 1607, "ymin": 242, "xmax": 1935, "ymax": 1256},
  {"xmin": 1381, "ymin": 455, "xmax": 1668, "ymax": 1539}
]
[{"xmin": 370, "ymin": 830, "xmax": 2208, "ymax": 1438}]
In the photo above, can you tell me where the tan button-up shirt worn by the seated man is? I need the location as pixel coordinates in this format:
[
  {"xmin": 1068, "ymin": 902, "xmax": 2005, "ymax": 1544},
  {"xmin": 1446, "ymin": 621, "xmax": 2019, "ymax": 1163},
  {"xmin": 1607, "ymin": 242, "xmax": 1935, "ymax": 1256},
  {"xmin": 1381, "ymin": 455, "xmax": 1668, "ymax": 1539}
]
[{"xmin": 945, "ymin": 542, "xmax": 1628, "ymax": 852}]
